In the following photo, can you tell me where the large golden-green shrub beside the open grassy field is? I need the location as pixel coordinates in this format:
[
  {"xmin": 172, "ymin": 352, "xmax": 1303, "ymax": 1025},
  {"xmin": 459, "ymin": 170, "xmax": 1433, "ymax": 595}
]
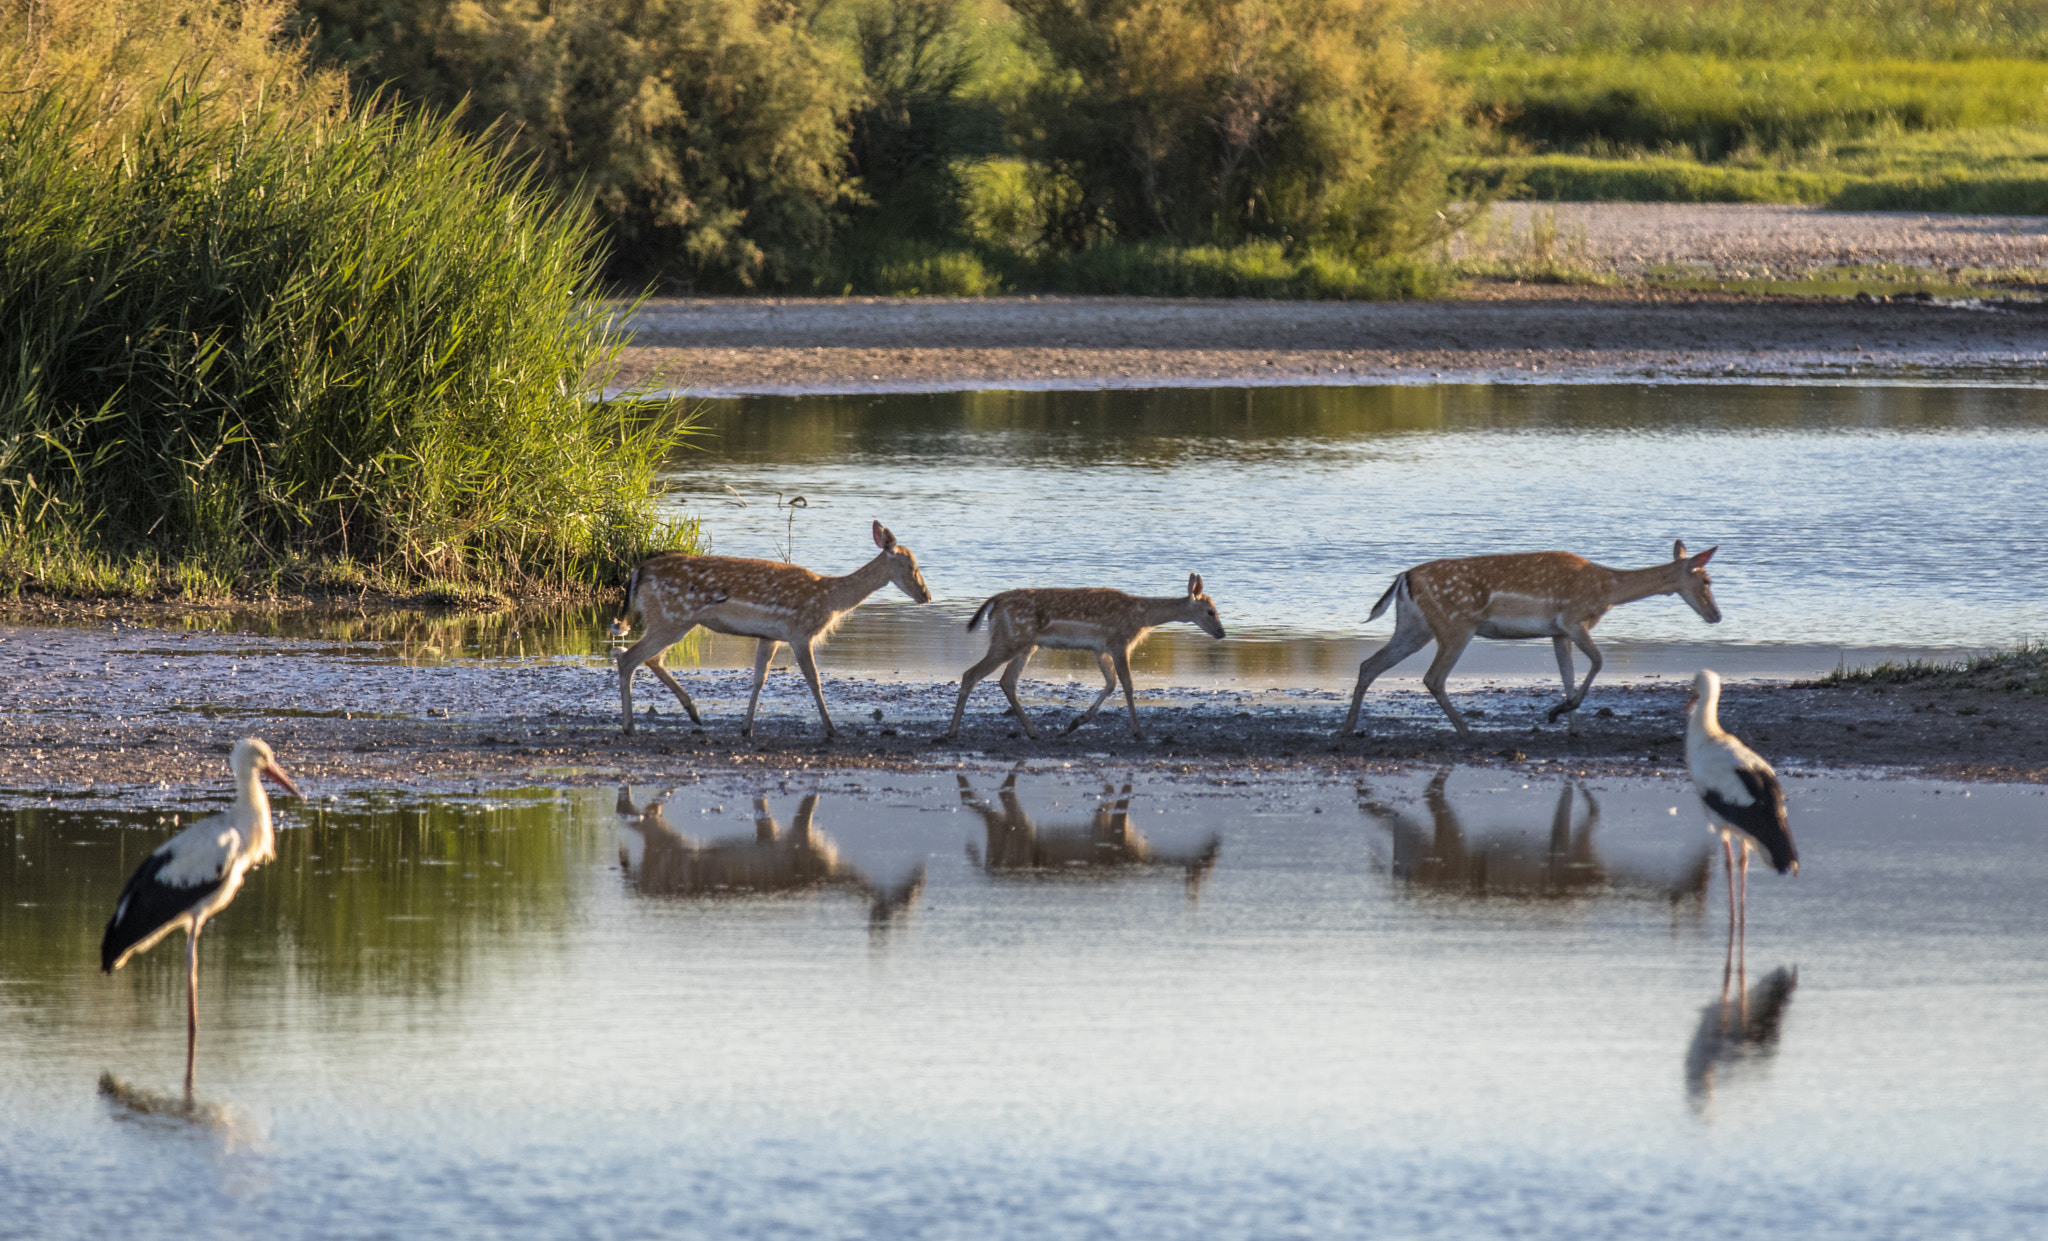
[{"xmin": 1012, "ymin": 0, "xmax": 1454, "ymax": 254}]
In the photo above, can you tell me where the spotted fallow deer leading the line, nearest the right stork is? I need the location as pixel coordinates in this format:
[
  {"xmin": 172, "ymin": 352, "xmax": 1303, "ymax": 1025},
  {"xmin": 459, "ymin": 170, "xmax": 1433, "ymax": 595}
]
[{"xmin": 1343, "ymin": 543, "xmax": 1720, "ymax": 739}]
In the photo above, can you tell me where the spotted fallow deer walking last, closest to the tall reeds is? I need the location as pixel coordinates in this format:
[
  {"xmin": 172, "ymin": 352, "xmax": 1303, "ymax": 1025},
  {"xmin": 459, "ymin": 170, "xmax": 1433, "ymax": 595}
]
[{"xmin": 612, "ymin": 522, "xmax": 932, "ymax": 741}]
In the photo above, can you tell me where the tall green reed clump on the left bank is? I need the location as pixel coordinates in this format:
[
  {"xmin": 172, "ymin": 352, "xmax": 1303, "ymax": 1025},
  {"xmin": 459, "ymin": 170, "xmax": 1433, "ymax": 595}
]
[{"xmin": 0, "ymin": 82, "xmax": 694, "ymax": 596}]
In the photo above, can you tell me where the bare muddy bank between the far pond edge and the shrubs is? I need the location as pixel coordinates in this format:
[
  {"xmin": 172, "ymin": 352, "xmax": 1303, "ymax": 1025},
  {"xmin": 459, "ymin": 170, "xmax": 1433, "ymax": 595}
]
[{"xmin": 608, "ymin": 285, "xmax": 2048, "ymax": 395}]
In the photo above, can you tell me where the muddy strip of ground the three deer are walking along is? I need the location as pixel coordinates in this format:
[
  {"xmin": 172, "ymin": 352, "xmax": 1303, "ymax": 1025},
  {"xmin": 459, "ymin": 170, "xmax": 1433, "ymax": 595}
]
[{"xmin": 0, "ymin": 625, "xmax": 2048, "ymax": 807}]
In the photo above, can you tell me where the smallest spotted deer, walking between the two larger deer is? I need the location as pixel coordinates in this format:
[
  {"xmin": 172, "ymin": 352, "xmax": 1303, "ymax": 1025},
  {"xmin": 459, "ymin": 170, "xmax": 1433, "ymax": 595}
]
[{"xmin": 946, "ymin": 573, "xmax": 1223, "ymax": 741}]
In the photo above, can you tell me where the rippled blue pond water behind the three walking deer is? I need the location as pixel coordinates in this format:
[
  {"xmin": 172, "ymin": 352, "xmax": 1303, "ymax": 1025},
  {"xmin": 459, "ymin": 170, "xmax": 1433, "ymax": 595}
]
[{"xmin": 655, "ymin": 385, "xmax": 2048, "ymax": 684}]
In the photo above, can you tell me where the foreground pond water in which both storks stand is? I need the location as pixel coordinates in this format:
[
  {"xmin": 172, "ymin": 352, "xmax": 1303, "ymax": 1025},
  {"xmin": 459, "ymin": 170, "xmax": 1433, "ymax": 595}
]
[{"xmin": 0, "ymin": 764, "xmax": 2048, "ymax": 1237}]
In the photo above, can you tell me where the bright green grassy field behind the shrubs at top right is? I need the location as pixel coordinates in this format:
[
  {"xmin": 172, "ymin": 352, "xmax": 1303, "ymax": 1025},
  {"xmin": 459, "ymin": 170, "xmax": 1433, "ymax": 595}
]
[{"xmin": 1409, "ymin": 0, "xmax": 2048, "ymax": 213}]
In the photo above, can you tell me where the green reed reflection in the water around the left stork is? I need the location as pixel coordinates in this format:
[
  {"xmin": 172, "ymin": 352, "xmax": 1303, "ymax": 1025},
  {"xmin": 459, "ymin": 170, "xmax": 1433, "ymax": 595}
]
[{"xmin": 0, "ymin": 790, "xmax": 602, "ymax": 1012}]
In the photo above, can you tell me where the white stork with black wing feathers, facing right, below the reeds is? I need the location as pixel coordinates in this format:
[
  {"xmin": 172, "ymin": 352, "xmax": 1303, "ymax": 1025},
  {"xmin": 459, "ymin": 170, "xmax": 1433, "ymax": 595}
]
[{"xmin": 100, "ymin": 737, "xmax": 301, "ymax": 1094}]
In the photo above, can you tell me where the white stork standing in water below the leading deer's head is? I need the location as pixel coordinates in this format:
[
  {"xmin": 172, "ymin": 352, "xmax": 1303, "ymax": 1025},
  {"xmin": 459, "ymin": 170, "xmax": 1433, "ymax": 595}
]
[{"xmin": 1686, "ymin": 668, "xmax": 1798, "ymax": 932}]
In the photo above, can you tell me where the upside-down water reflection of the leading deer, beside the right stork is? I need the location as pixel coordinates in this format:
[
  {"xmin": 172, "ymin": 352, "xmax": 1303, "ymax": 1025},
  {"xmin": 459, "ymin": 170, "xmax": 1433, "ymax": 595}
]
[{"xmin": 1358, "ymin": 768, "xmax": 1712, "ymax": 903}]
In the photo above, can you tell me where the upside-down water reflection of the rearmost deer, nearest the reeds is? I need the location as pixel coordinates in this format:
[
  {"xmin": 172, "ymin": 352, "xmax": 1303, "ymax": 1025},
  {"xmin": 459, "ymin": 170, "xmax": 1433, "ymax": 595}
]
[{"xmin": 618, "ymin": 786, "xmax": 924, "ymax": 928}]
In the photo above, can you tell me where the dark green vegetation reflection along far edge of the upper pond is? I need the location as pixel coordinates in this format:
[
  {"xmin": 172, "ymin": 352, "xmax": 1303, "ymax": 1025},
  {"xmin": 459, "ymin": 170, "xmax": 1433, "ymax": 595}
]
[{"xmin": 670, "ymin": 385, "xmax": 2040, "ymax": 473}]
